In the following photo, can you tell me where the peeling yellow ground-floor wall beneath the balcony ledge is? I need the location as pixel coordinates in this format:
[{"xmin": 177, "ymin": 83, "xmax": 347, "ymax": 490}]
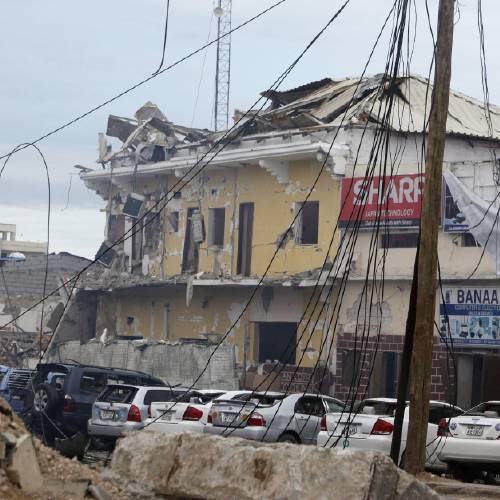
[{"xmin": 97, "ymin": 285, "xmax": 332, "ymax": 367}]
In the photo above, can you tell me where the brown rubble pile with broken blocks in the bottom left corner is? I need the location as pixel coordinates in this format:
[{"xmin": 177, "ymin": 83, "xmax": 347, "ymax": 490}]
[{"xmin": 0, "ymin": 398, "xmax": 134, "ymax": 500}]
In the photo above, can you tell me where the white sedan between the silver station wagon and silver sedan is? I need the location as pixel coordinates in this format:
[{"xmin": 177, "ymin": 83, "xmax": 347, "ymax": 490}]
[{"xmin": 147, "ymin": 390, "xmax": 252, "ymax": 433}]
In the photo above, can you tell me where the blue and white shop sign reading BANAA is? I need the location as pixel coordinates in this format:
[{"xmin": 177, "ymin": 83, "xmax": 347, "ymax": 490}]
[{"xmin": 439, "ymin": 286, "xmax": 500, "ymax": 347}]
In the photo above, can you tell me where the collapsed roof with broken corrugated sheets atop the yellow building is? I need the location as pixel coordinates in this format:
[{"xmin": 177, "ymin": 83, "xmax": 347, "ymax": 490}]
[{"xmin": 99, "ymin": 74, "xmax": 500, "ymax": 166}]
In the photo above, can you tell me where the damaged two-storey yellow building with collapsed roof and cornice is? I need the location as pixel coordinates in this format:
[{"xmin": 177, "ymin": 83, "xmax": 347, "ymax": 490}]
[{"xmin": 76, "ymin": 76, "xmax": 500, "ymax": 400}]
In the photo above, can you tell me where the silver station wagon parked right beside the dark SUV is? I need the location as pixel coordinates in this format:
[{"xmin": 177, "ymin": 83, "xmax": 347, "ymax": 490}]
[{"xmin": 87, "ymin": 384, "xmax": 187, "ymax": 445}]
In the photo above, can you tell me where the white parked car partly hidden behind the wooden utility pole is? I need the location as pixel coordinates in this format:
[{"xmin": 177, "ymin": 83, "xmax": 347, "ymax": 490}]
[{"xmin": 317, "ymin": 398, "xmax": 463, "ymax": 471}]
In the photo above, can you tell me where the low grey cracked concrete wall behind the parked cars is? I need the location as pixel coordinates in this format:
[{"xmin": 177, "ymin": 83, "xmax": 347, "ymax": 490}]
[{"xmin": 47, "ymin": 340, "xmax": 238, "ymax": 390}]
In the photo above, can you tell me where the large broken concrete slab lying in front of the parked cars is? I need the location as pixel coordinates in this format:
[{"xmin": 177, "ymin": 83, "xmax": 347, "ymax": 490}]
[{"xmin": 111, "ymin": 431, "xmax": 440, "ymax": 500}]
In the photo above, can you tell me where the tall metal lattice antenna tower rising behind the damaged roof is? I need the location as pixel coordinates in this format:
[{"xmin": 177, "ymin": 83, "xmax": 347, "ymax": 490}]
[{"xmin": 214, "ymin": 0, "xmax": 232, "ymax": 131}]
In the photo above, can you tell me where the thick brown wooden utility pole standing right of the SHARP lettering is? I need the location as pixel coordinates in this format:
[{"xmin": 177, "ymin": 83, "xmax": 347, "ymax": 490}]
[{"xmin": 405, "ymin": 0, "xmax": 455, "ymax": 474}]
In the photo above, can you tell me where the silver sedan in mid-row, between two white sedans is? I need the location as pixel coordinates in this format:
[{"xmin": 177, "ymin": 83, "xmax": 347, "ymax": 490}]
[{"xmin": 205, "ymin": 392, "xmax": 345, "ymax": 444}]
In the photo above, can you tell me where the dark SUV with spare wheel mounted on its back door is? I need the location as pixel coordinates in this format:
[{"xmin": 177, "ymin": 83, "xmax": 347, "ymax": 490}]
[{"xmin": 26, "ymin": 363, "xmax": 166, "ymax": 451}]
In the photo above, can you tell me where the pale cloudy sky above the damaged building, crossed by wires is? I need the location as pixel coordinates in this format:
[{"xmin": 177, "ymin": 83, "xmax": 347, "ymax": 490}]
[{"xmin": 0, "ymin": 0, "xmax": 500, "ymax": 257}]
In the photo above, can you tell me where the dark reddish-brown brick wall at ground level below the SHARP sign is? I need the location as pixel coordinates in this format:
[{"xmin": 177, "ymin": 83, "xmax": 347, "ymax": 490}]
[{"xmin": 334, "ymin": 334, "xmax": 459, "ymax": 401}]
